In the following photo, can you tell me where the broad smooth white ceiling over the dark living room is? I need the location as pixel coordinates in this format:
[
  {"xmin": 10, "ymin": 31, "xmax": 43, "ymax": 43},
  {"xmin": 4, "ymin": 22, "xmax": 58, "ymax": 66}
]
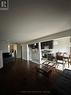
[{"xmin": 0, "ymin": 0, "xmax": 71, "ymax": 42}]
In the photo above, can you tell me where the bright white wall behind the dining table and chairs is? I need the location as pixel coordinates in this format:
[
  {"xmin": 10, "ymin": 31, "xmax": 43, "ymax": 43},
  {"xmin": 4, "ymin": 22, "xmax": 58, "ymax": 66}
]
[{"xmin": 53, "ymin": 37, "xmax": 70, "ymax": 54}]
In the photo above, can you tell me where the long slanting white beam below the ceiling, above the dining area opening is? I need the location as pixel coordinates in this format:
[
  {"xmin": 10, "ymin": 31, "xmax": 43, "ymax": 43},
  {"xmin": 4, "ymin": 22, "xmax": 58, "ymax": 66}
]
[{"xmin": 26, "ymin": 30, "xmax": 71, "ymax": 44}]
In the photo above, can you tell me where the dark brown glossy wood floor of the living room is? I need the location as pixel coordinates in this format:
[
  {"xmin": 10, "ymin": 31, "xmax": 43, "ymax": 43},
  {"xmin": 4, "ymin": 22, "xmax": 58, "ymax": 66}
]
[{"xmin": 0, "ymin": 59, "xmax": 60, "ymax": 95}]
